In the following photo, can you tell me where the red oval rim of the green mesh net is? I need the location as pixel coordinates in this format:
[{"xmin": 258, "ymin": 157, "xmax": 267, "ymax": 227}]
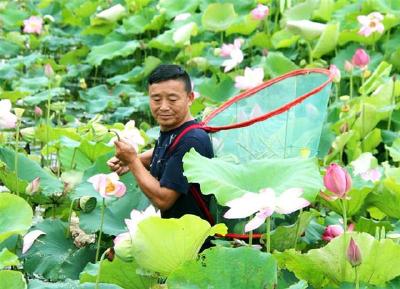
[{"xmin": 201, "ymin": 68, "xmax": 334, "ymax": 132}]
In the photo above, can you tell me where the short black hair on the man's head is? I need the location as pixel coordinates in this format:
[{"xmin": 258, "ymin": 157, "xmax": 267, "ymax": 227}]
[{"xmin": 147, "ymin": 64, "xmax": 192, "ymax": 93}]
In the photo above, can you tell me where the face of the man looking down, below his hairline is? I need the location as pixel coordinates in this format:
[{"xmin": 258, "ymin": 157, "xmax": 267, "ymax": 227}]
[{"xmin": 149, "ymin": 79, "xmax": 194, "ymax": 131}]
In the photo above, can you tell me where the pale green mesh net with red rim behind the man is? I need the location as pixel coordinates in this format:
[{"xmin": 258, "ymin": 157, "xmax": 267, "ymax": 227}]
[{"xmin": 203, "ymin": 69, "xmax": 333, "ymax": 162}]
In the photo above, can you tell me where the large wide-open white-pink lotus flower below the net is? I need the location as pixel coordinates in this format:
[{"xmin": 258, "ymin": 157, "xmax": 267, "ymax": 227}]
[{"xmin": 224, "ymin": 188, "xmax": 310, "ymax": 232}]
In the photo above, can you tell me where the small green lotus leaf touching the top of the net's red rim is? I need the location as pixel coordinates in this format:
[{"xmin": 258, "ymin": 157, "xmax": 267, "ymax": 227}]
[{"xmin": 263, "ymin": 52, "xmax": 298, "ymax": 77}]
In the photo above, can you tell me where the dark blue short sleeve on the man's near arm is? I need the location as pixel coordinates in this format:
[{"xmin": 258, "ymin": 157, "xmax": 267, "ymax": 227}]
[{"xmin": 160, "ymin": 137, "xmax": 206, "ymax": 194}]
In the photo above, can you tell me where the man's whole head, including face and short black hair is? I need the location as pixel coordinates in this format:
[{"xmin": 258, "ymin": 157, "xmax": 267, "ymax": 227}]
[{"xmin": 148, "ymin": 64, "xmax": 194, "ymax": 131}]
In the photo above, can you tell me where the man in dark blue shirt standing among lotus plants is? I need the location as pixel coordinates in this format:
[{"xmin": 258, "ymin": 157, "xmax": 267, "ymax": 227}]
[{"xmin": 108, "ymin": 65, "xmax": 213, "ymax": 219}]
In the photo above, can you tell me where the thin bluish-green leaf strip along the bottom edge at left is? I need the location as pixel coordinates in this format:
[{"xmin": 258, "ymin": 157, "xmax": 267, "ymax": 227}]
[{"xmin": 28, "ymin": 279, "xmax": 122, "ymax": 289}]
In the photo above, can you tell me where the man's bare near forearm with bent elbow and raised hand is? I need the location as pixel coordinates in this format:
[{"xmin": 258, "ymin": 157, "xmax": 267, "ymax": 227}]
[{"xmin": 115, "ymin": 140, "xmax": 179, "ymax": 211}]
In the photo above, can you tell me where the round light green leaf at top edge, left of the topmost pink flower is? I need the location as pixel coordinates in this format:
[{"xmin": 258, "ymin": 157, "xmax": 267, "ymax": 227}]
[{"xmin": 201, "ymin": 3, "xmax": 237, "ymax": 32}]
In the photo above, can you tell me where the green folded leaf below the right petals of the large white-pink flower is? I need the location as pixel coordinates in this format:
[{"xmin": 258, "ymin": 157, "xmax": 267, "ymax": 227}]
[{"xmin": 271, "ymin": 212, "xmax": 315, "ymax": 251}]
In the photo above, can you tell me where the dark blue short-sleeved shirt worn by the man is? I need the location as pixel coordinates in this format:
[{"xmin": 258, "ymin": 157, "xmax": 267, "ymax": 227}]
[{"xmin": 150, "ymin": 120, "xmax": 214, "ymax": 219}]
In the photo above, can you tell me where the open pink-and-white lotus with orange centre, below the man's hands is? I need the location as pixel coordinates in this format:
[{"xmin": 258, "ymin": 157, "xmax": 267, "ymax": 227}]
[{"xmin": 88, "ymin": 172, "xmax": 126, "ymax": 198}]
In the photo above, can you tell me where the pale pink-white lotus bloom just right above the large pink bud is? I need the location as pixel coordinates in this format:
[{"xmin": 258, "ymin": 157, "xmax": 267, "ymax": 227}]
[{"xmin": 350, "ymin": 152, "xmax": 382, "ymax": 182}]
